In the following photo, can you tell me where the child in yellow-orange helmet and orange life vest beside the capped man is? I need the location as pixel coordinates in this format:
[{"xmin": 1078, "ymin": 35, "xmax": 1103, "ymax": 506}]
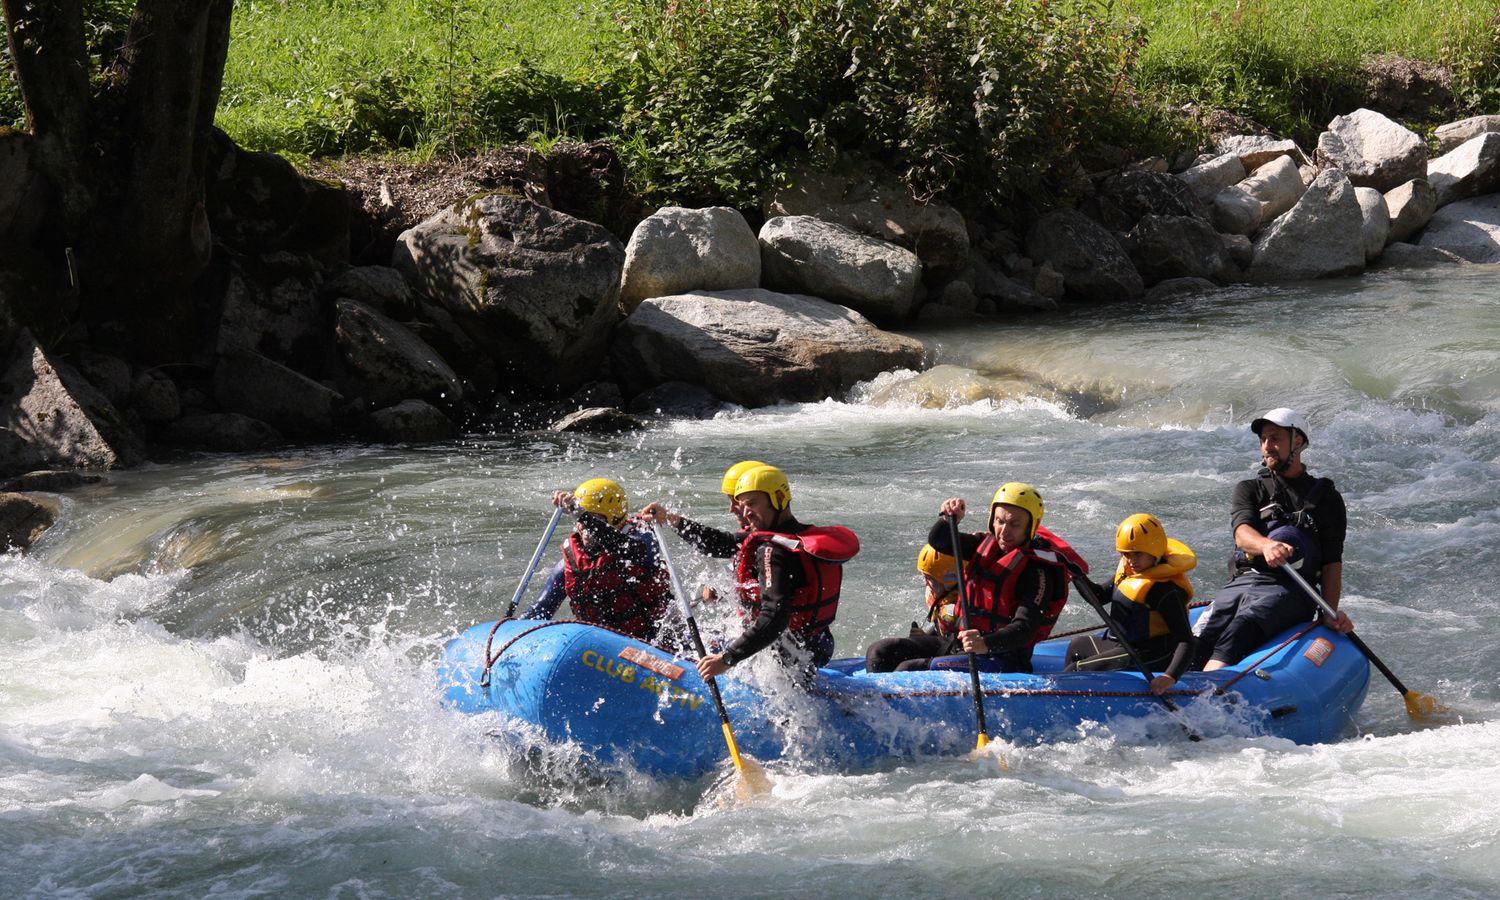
[{"xmin": 1067, "ymin": 513, "xmax": 1199, "ymax": 693}]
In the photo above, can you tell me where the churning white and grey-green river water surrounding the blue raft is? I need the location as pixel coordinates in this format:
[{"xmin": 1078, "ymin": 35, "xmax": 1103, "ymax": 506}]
[{"xmin": 0, "ymin": 267, "xmax": 1500, "ymax": 899}]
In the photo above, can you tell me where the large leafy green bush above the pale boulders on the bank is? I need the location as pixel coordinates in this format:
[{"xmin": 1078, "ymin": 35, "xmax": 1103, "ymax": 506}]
[{"xmin": 614, "ymin": 0, "xmax": 1142, "ymax": 204}]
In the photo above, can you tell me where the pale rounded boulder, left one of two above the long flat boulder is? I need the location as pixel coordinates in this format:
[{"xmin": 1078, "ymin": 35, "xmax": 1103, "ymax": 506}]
[{"xmin": 620, "ymin": 207, "xmax": 761, "ymax": 312}]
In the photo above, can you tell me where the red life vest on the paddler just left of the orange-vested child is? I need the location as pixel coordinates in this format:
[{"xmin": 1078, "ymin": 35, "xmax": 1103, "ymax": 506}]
[{"xmin": 965, "ymin": 528, "xmax": 1089, "ymax": 647}]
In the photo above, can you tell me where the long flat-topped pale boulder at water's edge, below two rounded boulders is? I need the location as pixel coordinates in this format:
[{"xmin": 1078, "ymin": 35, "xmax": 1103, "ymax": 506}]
[{"xmin": 611, "ymin": 290, "xmax": 924, "ymax": 407}]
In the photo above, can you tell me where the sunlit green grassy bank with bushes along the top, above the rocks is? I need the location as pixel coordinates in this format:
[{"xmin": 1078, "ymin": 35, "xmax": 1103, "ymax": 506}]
[{"xmin": 0, "ymin": 0, "xmax": 1500, "ymax": 201}]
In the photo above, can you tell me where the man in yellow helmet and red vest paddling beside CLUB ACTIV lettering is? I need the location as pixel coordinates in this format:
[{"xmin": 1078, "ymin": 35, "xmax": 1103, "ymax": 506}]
[{"xmin": 642, "ymin": 464, "xmax": 860, "ymax": 681}]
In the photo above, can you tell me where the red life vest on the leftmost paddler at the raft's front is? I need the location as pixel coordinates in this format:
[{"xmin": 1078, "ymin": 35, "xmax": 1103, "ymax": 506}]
[{"xmin": 563, "ymin": 534, "xmax": 672, "ymax": 641}]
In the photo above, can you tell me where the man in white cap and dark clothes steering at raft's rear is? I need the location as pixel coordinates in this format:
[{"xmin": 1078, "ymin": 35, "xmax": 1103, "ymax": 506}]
[{"xmin": 1197, "ymin": 407, "xmax": 1355, "ymax": 672}]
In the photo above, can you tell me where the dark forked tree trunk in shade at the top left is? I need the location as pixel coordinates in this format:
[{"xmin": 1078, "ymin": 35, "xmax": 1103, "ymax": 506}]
[{"xmin": 5, "ymin": 0, "xmax": 234, "ymax": 362}]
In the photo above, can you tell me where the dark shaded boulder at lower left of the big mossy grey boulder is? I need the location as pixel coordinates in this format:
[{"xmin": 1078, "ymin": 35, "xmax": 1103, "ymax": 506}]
[{"xmin": 333, "ymin": 300, "xmax": 464, "ymax": 408}]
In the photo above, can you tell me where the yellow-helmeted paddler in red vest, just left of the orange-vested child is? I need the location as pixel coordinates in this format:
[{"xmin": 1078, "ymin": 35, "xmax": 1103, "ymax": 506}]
[{"xmin": 866, "ymin": 482, "xmax": 1088, "ymax": 672}]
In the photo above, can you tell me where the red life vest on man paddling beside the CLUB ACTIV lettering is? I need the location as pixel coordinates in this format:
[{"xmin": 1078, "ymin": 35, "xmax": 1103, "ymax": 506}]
[{"xmin": 735, "ymin": 525, "xmax": 860, "ymax": 638}]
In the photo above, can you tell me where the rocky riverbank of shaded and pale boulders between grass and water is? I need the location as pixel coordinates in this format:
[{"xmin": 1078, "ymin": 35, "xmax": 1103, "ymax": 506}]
[{"xmin": 0, "ymin": 110, "xmax": 1500, "ymax": 543}]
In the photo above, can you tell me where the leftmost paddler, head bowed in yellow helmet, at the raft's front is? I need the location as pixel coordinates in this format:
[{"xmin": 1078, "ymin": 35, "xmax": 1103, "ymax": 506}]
[{"xmin": 521, "ymin": 479, "xmax": 675, "ymax": 644}]
